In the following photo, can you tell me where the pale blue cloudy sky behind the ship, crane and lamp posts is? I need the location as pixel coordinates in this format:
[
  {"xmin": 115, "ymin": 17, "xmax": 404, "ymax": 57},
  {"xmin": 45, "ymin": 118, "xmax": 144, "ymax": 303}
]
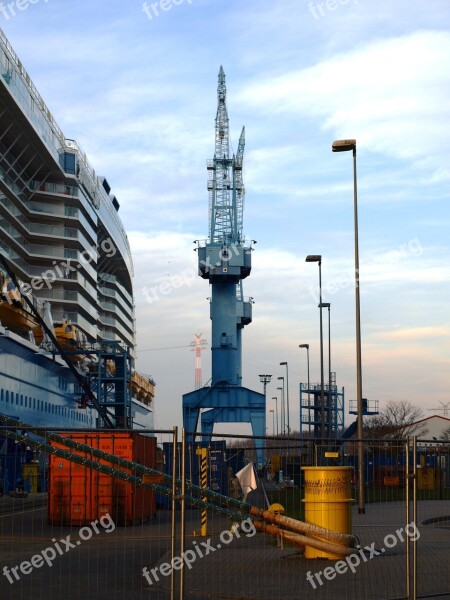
[{"xmin": 0, "ymin": 0, "xmax": 450, "ymax": 431}]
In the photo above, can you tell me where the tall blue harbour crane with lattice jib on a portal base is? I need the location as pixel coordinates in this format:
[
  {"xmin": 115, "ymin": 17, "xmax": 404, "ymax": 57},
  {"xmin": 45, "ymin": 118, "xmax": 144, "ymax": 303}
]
[{"xmin": 183, "ymin": 67, "xmax": 266, "ymax": 464}]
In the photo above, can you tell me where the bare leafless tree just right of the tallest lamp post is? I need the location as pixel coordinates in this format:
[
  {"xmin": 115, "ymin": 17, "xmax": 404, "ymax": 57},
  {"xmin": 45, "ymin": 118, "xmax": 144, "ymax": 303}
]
[{"xmin": 364, "ymin": 400, "xmax": 427, "ymax": 440}]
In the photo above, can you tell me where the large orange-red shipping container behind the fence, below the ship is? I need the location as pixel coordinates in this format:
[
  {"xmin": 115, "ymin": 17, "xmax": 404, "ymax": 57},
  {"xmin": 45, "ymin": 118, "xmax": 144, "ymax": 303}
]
[{"xmin": 48, "ymin": 432, "xmax": 157, "ymax": 525}]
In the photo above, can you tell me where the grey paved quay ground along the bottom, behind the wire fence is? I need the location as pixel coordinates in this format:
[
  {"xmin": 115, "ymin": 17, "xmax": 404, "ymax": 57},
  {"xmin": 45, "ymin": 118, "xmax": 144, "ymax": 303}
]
[{"xmin": 0, "ymin": 495, "xmax": 450, "ymax": 600}]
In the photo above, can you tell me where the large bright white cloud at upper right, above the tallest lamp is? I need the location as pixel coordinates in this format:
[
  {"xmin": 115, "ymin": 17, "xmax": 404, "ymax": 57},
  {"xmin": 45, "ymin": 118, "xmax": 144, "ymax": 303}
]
[{"xmin": 240, "ymin": 31, "xmax": 450, "ymax": 168}]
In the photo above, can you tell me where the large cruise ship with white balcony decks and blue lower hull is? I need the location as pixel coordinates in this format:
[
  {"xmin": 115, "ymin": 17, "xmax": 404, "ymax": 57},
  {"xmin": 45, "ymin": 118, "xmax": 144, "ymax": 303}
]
[{"xmin": 0, "ymin": 30, "xmax": 154, "ymax": 434}]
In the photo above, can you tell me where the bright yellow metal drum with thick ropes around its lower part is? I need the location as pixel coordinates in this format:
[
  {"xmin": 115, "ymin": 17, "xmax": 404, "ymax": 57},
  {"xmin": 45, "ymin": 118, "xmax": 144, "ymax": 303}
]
[{"xmin": 302, "ymin": 467, "xmax": 353, "ymax": 559}]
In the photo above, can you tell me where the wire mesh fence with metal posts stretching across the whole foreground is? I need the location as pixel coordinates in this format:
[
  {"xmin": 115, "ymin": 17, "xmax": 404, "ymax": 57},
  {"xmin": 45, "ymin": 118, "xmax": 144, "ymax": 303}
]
[{"xmin": 0, "ymin": 419, "xmax": 450, "ymax": 600}]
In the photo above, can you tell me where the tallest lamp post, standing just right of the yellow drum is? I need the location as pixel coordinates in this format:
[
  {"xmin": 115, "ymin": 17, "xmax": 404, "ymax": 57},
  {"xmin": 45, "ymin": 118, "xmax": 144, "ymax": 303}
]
[{"xmin": 331, "ymin": 140, "xmax": 366, "ymax": 514}]
